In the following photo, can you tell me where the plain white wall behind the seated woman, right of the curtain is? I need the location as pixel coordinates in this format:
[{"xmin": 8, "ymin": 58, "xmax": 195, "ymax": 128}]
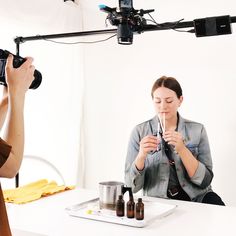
[{"xmin": 81, "ymin": 0, "xmax": 236, "ymax": 205}]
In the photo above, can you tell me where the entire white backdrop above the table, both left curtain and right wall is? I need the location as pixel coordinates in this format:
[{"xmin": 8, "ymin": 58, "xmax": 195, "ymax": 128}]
[{"xmin": 0, "ymin": 0, "xmax": 236, "ymax": 206}]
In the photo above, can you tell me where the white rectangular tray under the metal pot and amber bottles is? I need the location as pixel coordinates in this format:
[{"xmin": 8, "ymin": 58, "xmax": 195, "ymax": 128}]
[{"xmin": 66, "ymin": 198, "xmax": 177, "ymax": 227}]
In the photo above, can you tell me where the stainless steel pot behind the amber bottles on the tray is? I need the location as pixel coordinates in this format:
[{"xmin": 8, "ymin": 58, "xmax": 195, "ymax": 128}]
[{"xmin": 99, "ymin": 181, "xmax": 124, "ymax": 210}]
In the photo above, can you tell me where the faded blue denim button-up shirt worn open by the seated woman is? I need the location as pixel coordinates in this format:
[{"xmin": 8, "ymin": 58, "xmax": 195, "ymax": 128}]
[{"xmin": 125, "ymin": 116, "xmax": 213, "ymax": 202}]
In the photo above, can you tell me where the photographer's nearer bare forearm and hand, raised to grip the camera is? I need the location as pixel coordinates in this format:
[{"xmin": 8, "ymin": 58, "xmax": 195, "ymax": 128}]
[{"xmin": 0, "ymin": 55, "xmax": 35, "ymax": 178}]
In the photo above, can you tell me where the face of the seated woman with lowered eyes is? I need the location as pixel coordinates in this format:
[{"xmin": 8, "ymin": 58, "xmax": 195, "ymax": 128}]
[{"xmin": 153, "ymin": 87, "xmax": 183, "ymax": 120}]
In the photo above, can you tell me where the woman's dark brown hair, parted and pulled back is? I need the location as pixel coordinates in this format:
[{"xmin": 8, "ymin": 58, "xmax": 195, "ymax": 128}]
[{"xmin": 151, "ymin": 76, "xmax": 182, "ymax": 98}]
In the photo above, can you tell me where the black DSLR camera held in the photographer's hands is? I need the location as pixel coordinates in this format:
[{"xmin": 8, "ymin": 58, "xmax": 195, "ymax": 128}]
[{"xmin": 0, "ymin": 49, "xmax": 42, "ymax": 89}]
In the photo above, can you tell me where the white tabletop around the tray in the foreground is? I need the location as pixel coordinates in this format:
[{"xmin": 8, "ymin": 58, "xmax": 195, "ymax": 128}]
[{"xmin": 7, "ymin": 189, "xmax": 236, "ymax": 236}]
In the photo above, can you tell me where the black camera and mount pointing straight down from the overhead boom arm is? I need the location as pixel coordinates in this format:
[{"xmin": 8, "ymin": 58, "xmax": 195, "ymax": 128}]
[{"xmin": 99, "ymin": 0, "xmax": 154, "ymax": 45}]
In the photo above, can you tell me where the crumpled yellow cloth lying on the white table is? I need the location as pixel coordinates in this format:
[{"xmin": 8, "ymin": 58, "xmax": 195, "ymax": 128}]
[{"xmin": 3, "ymin": 179, "xmax": 75, "ymax": 204}]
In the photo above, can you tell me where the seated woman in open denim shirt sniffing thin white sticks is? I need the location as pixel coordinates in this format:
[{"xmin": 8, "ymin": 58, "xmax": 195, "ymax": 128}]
[{"xmin": 125, "ymin": 76, "xmax": 225, "ymax": 205}]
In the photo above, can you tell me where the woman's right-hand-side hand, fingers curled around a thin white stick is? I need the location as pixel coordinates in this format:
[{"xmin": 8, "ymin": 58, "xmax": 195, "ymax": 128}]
[{"xmin": 163, "ymin": 131, "xmax": 185, "ymax": 152}]
